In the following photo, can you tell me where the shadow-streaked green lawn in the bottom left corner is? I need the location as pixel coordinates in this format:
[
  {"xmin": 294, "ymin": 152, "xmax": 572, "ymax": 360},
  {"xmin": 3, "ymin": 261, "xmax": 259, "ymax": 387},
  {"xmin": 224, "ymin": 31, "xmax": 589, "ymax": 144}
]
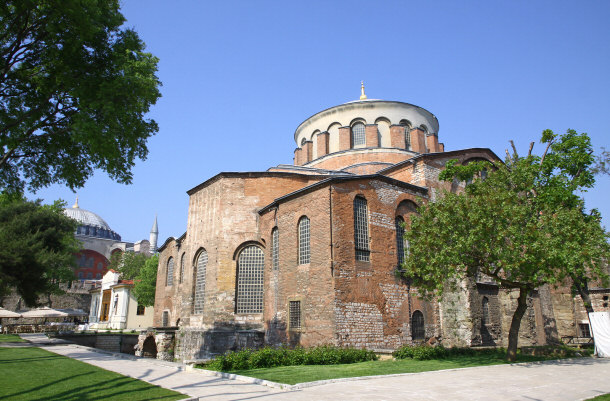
[{"xmin": 0, "ymin": 347, "xmax": 186, "ymax": 401}]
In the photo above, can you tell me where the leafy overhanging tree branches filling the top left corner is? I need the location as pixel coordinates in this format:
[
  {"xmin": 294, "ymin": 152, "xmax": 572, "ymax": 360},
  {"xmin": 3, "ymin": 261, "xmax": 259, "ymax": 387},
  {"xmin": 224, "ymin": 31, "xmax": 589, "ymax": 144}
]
[{"xmin": 0, "ymin": 0, "xmax": 160, "ymax": 192}]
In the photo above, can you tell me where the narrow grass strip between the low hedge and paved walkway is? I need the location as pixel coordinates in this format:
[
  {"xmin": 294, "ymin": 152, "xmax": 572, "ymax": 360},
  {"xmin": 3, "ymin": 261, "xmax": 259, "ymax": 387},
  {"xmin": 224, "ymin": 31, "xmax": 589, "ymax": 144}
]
[{"xmin": 202, "ymin": 352, "xmax": 588, "ymax": 384}]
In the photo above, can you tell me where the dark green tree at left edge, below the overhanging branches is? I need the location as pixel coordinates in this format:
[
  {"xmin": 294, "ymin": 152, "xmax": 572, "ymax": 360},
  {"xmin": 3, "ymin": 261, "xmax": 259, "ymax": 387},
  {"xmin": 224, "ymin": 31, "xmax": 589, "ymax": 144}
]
[{"xmin": 0, "ymin": 194, "xmax": 80, "ymax": 306}]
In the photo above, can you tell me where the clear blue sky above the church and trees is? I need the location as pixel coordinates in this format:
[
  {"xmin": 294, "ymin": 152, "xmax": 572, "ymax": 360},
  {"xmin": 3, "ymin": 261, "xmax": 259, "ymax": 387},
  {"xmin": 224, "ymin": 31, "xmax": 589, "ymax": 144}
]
[{"xmin": 29, "ymin": 0, "xmax": 610, "ymax": 244}]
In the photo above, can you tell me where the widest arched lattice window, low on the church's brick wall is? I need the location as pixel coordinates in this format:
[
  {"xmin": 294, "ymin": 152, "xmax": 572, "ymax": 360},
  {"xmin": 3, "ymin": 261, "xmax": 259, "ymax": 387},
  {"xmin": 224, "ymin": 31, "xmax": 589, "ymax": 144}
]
[{"xmin": 235, "ymin": 245, "xmax": 265, "ymax": 313}]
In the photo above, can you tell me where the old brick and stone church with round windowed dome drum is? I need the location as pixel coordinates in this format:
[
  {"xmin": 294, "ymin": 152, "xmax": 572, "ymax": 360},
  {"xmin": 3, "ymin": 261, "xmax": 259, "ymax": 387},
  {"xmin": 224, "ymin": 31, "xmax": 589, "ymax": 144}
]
[{"xmin": 154, "ymin": 87, "xmax": 608, "ymax": 360}]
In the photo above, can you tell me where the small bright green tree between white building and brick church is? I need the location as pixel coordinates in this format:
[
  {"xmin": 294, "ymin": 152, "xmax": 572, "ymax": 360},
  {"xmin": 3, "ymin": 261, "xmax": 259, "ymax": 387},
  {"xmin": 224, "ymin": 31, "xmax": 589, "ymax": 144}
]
[{"xmin": 108, "ymin": 252, "xmax": 159, "ymax": 306}]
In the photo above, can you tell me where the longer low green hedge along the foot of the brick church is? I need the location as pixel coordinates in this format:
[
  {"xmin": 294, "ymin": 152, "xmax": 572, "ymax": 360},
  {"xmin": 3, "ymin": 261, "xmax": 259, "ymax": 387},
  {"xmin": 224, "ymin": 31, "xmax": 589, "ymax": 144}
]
[{"xmin": 207, "ymin": 345, "xmax": 377, "ymax": 371}]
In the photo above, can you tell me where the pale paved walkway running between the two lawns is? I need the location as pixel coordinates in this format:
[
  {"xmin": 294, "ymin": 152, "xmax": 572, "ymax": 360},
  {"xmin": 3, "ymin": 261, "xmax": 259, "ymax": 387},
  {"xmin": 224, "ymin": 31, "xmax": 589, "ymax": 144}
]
[{"xmin": 8, "ymin": 335, "xmax": 610, "ymax": 401}]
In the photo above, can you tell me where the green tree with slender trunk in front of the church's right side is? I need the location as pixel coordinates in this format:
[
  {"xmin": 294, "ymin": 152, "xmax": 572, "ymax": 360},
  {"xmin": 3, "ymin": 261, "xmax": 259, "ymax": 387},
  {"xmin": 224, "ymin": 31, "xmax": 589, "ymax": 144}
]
[{"xmin": 404, "ymin": 130, "xmax": 610, "ymax": 361}]
